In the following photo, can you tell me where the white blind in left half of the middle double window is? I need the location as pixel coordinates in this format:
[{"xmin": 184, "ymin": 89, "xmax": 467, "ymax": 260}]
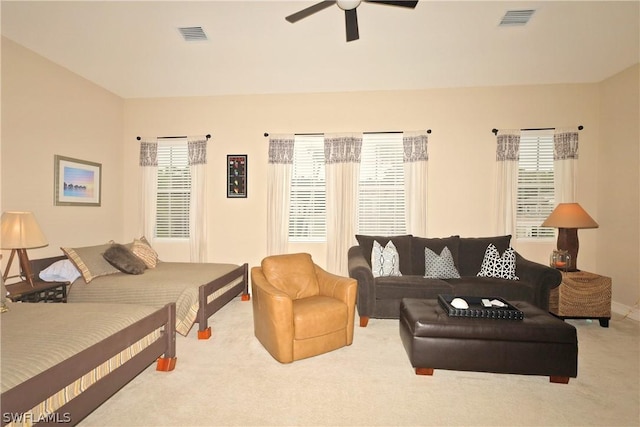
[{"xmin": 289, "ymin": 135, "xmax": 327, "ymax": 242}]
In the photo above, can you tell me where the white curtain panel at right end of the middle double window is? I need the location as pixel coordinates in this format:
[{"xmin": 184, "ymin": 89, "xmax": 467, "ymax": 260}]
[{"xmin": 402, "ymin": 131, "xmax": 429, "ymax": 236}]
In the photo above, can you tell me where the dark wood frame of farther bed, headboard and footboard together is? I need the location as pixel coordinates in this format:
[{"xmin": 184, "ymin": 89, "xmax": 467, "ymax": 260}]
[{"xmin": 29, "ymin": 255, "xmax": 251, "ymax": 340}]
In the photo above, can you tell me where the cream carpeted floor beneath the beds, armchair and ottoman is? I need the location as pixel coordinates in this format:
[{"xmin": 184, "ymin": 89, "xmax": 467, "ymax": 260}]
[{"xmin": 80, "ymin": 299, "xmax": 640, "ymax": 427}]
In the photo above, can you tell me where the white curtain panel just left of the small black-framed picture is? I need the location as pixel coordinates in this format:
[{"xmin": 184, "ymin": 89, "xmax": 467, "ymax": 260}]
[{"xmin": 187, "ymin": 136, "xmax": 207, "ymax": 262}]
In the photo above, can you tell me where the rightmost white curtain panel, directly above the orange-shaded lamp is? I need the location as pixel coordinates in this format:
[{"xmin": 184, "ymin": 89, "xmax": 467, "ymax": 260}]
[{"xmin": 553, "ymin": 129, "xmax": 578, "ymax": 204}]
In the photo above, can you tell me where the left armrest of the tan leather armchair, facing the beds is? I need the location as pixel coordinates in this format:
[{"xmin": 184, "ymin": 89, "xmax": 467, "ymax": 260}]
[{"xmin": 251, "ymin": 267, "xmax": 294, "ymax": 361}]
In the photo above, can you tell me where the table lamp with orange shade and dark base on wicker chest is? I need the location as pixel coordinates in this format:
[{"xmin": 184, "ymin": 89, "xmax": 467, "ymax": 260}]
[{"xmin": 542, "ymin": 203, "xmax": 598, "ymax": 271}]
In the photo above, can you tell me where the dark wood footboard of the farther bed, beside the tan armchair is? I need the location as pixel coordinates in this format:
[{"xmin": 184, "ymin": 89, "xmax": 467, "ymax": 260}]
[{"xmin": 197, "ymin": 263, "xmax": 250, "ymax": 340}]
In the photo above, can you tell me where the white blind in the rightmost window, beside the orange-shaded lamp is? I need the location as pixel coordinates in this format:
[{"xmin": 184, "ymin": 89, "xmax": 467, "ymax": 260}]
[{"xmin": 516, "ymin": 130, "xmax": 555, "ymax": 239}]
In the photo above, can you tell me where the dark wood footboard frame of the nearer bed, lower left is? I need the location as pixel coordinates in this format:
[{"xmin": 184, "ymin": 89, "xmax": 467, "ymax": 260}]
[{"xmin": 1, "ymin": 303, "xmax": 176, "ymax": 426}]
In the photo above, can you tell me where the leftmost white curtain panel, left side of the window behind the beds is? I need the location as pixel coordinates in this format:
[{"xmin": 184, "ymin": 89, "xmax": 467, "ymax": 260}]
[{"xmin": 140, "ymin": 138, "xmax": 158, "ymax": 242}]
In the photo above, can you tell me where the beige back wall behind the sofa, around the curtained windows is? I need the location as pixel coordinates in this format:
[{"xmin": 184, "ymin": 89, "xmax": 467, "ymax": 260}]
[{"xmin": 124, "ymin": 85, "xmax": 599, "ymax": 269}]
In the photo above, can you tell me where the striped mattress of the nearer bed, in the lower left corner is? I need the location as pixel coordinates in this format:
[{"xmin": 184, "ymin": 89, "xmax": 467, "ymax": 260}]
[{"xmin": 0, "ymin": 302, "xmax": 161, "ymax": 425}]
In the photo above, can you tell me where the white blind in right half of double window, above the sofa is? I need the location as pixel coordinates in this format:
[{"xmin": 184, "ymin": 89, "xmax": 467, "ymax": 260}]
[{"xmin": 358, "ymin": 133, "xmax": 406, "ymax": 236}]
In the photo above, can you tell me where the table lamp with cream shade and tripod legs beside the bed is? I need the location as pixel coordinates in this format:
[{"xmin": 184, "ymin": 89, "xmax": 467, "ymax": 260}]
[{"xmin": 0, "ymin": 212, "xmax": 48, "ymax": 287}]
